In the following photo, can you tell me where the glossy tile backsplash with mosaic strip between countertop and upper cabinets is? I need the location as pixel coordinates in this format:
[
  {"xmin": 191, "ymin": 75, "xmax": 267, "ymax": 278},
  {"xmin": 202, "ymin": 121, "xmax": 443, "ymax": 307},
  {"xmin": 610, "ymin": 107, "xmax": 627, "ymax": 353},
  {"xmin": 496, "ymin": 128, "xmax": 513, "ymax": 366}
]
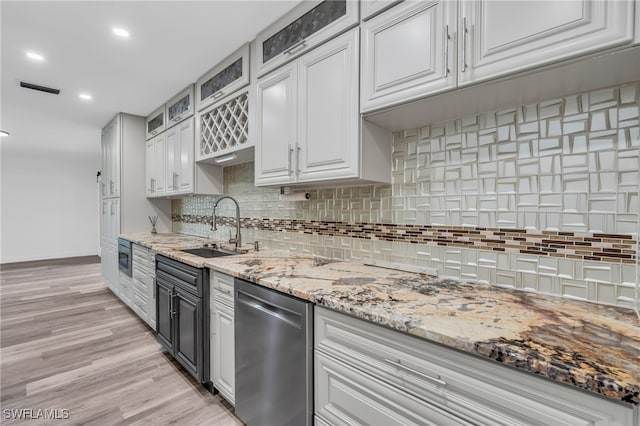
[{"xmin": 172, "ymin": 82, "xmax": 640, "ymax": 306}]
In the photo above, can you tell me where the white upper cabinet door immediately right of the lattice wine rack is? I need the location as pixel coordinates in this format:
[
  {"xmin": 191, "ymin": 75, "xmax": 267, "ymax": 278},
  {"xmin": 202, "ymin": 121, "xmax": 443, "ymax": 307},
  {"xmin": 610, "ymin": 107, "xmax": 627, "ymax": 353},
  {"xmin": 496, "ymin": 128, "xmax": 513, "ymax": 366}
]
[{"xmin": 255, "ymin": 62, "xmax": 297, "ymax": 186}]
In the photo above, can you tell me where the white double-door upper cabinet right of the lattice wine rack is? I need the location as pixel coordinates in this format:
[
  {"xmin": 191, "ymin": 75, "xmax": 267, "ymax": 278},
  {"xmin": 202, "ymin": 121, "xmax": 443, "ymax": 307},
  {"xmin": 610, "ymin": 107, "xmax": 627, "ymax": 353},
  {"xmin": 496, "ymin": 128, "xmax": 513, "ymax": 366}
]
[{"xmin": 255, "ymin": 29, "xmax": 391, "ymax": 186}]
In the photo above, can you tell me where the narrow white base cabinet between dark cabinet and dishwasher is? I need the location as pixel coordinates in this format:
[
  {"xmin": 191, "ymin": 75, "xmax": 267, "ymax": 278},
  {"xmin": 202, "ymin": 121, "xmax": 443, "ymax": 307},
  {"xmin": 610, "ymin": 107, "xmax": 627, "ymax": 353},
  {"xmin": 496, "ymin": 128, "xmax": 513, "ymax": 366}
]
[{"xmin": 210, "ymin": 271, "xmax": 235, "ymax": 404}]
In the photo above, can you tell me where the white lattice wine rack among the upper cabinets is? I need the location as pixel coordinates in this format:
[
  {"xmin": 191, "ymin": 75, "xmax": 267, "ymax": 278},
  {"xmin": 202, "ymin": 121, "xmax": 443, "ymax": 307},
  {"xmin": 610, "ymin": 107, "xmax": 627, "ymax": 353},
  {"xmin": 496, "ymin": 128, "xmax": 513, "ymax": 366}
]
[{"xmin": 199, "ymin": 92, "xmax": 249, "ymax": 158}]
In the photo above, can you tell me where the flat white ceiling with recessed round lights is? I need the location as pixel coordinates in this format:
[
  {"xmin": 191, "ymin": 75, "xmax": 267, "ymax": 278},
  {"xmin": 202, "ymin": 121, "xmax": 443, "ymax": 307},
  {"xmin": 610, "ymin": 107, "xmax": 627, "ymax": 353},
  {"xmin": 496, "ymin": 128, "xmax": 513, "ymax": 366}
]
[{"xmin": 0, "ymin": 0, "xmax": 299, "ymax": 152}]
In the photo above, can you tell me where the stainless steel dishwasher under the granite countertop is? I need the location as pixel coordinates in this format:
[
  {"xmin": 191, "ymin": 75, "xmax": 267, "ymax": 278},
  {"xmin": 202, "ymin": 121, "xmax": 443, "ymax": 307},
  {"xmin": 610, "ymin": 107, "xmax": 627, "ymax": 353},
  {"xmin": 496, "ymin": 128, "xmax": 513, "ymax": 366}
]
[{"xmin": 234, "ymin": 278, "xmax": 313, "ymax": 426}]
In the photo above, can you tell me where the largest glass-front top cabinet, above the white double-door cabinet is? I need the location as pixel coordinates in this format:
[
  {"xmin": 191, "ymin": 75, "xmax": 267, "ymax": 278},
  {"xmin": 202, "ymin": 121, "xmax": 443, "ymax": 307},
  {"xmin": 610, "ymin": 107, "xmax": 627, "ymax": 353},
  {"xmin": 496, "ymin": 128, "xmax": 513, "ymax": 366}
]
[{"xmin": 254, "ymin": 0, "xmax": 359, "ymax": 75}]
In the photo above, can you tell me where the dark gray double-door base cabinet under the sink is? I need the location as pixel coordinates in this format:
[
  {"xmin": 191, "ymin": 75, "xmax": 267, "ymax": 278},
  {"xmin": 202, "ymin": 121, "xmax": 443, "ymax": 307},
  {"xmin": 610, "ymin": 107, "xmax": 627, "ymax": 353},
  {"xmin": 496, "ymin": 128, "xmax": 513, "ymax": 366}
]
[{"xmin": 156, "ymin": 256, "xmax": 209, "ymax": 383}]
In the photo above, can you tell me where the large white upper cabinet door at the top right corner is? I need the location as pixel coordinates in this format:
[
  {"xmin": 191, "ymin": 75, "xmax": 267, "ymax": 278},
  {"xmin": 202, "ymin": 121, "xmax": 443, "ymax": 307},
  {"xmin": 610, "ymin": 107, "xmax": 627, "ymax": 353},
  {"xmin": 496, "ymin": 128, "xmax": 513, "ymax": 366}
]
[{"xmin": 458, "ymin": 0, "xmax": 634, "ymax": 85}]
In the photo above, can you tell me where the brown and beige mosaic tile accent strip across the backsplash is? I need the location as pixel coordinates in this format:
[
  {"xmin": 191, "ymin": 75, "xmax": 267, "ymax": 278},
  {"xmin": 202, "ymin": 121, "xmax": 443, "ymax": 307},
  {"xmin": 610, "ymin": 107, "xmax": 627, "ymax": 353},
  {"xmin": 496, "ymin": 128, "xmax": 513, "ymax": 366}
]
[{"xmin": 172, "ymin": 214, "xmax": 636, "ymax": 264}]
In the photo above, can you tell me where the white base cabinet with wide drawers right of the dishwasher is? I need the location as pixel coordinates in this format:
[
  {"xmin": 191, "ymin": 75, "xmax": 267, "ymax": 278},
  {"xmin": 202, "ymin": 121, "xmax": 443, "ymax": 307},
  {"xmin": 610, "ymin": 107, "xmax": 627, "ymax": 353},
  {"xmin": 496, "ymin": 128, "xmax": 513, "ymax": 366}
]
[{"xmin": 314, "ymin": 307, "xmax": 634, "ymax": 426}]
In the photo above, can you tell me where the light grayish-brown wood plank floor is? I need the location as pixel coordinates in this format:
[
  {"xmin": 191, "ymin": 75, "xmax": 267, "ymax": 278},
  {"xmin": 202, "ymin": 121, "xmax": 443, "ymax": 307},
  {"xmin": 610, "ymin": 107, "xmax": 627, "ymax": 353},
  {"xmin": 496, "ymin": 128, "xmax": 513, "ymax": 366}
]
[{"xmin": 0, "ymin": 258, "xmax": 242, "ymax": 425}]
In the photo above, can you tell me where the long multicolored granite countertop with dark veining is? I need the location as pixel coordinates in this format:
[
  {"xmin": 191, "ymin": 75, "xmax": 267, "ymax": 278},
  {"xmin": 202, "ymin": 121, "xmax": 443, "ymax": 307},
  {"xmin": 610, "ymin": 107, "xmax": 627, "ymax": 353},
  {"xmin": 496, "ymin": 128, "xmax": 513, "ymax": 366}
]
[{"xmin": 123, "ymin": 234, "xmax": 640, "ymax": 405}]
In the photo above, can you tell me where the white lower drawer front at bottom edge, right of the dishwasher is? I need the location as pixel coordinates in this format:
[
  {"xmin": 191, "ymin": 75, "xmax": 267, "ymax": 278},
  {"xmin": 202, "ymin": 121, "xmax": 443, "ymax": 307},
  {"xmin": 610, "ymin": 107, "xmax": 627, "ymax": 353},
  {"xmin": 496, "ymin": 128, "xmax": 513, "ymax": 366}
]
[{"xmin": 314, "ymin": 352, "xmax": 471, "ymax": 426}]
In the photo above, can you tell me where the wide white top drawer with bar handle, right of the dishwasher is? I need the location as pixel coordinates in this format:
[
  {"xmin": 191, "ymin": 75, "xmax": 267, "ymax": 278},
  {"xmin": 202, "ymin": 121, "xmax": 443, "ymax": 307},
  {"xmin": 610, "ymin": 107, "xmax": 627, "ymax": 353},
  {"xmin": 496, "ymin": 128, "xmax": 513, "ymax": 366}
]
[{"xmin": 315, "ymin": 308, "xmax": 633, "ymax": 425}]
